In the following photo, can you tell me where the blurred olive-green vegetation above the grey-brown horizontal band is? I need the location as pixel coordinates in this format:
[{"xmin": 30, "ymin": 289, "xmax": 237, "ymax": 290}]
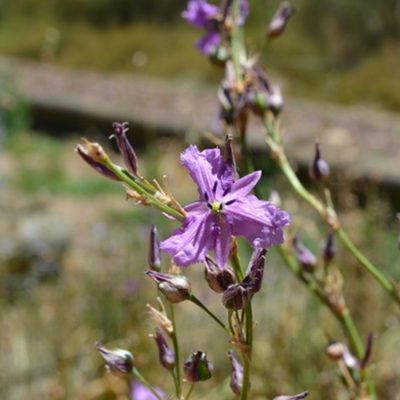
[{"xmin": 0, "ymin": 0, "xmax": 400, "ymax": 110}]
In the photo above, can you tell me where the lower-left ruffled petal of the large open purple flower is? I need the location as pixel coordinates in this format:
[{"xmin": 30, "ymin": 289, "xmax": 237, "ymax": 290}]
[{"xmin": 160, "ymin": 213, "xmax": 213, "ymax": 267}]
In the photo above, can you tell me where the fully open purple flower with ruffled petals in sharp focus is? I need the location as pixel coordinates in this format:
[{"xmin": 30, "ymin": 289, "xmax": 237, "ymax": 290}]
[{"xmin": 161, "ymin": 146, "xmax": 290, "ymax": 268}]
